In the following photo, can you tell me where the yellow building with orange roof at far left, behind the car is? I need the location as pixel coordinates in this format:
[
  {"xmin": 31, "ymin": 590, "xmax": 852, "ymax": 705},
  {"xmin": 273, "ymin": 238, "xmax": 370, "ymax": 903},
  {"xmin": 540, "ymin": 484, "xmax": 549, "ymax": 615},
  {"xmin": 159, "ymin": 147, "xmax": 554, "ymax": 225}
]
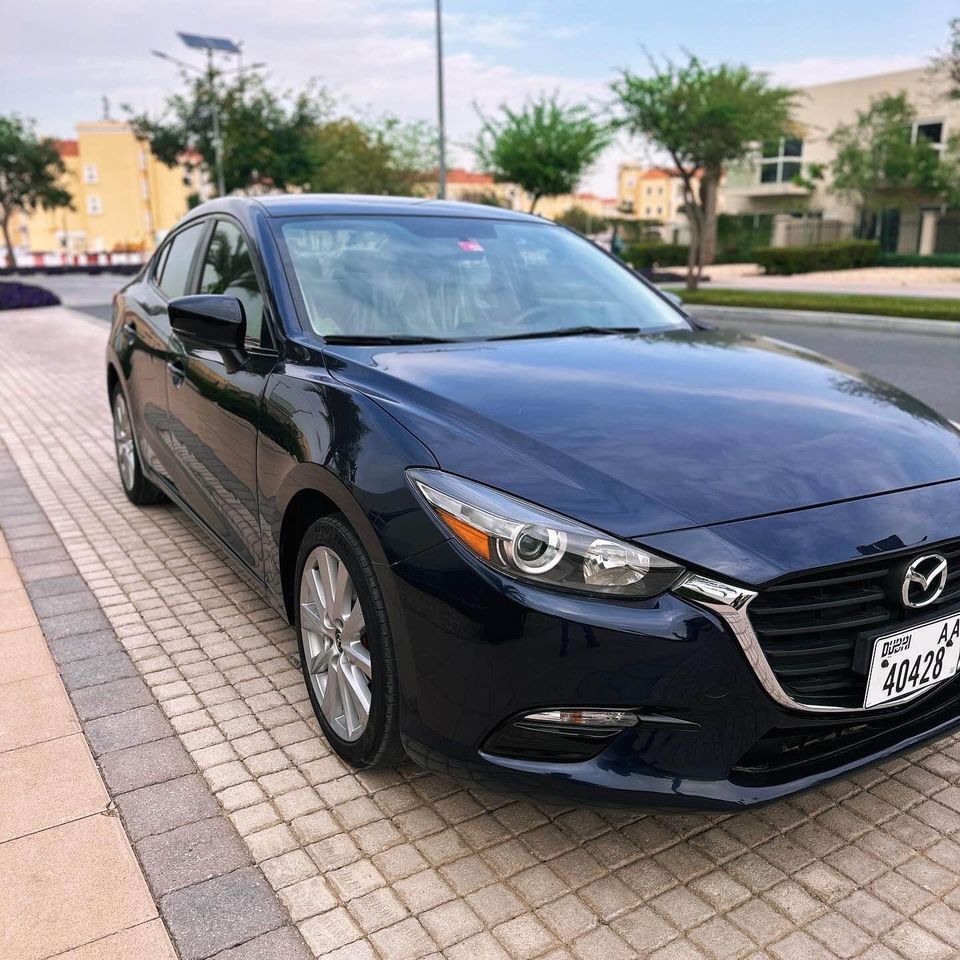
[{"xmin": 11, "ymin": 120, "xmax": 202, "ymax": 260}]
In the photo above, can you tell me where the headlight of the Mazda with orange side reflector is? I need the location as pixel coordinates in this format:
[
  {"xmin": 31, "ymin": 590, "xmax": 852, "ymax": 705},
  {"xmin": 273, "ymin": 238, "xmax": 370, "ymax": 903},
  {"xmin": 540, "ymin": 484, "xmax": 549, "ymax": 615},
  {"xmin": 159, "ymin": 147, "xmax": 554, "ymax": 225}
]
[{"xmin": 407, "ymin": 468, "xmax": 684, "ymax": 597}]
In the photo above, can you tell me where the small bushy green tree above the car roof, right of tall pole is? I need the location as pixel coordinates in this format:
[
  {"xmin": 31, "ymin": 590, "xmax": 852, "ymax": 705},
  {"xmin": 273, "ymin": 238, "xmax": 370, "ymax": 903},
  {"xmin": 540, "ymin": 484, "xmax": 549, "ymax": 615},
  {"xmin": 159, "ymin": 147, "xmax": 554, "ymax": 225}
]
[{"xmin": 474, "ymin": 95, "xmax": 612, "ymax": 213}]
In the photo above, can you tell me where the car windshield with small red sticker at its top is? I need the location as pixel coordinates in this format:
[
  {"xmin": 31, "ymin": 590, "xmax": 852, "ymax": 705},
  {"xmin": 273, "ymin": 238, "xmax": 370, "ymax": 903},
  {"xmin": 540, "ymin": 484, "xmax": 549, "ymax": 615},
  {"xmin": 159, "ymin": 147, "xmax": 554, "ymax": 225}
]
[{"xmin": 280, "ymin": 216, "xmax": 689, "ymax": 340}]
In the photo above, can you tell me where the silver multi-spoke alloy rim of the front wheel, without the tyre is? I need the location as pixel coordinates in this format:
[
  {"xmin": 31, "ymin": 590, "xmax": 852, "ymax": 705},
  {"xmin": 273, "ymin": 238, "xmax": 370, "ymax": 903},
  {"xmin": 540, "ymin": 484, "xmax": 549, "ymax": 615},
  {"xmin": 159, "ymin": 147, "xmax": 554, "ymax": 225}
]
[{"xmin": 300, "ymin": 547, "xmax": 373, "ymax": 741}]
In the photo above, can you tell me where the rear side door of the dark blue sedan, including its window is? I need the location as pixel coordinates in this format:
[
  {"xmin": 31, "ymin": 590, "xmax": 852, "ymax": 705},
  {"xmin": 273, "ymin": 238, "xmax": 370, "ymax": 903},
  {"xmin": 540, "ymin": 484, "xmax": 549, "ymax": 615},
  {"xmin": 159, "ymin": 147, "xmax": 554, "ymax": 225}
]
[{"xmin": 117, "ymin": 222, "xmax": 205, "ymax": 482}]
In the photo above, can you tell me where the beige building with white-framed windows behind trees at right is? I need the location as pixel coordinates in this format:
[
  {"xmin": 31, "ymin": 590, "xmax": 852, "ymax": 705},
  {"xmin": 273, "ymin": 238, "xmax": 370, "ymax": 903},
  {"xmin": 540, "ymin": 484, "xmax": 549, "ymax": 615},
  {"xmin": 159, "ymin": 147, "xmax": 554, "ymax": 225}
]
[{"xmin": 720, "ymin": 68, "xmax": 960, "ymax": 254}]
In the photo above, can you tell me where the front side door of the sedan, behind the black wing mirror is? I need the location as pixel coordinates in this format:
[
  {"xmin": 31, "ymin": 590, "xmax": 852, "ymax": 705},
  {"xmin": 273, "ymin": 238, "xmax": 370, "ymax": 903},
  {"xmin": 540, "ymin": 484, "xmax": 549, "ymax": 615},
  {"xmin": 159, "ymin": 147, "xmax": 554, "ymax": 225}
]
[{"xmin": 167, "ymin": 216, "xmax": 277, "ymax": 570}]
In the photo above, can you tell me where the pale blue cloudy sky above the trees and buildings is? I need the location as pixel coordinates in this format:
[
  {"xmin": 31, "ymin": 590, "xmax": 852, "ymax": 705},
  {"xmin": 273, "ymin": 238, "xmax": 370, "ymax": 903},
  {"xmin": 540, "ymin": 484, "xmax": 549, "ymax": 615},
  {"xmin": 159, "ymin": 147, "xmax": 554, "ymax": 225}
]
[{"xmin": 0, "ymin": 0, "xmax": 960, "ymax": 196}]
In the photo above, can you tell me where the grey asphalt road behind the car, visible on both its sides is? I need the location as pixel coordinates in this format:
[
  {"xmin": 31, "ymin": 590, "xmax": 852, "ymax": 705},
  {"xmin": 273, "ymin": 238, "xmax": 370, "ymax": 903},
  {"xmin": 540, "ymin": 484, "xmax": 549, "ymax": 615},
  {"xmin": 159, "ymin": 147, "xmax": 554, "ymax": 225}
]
[{"xmin": 25, "ymin": 273, "xmax": 960, "ymax": 421}]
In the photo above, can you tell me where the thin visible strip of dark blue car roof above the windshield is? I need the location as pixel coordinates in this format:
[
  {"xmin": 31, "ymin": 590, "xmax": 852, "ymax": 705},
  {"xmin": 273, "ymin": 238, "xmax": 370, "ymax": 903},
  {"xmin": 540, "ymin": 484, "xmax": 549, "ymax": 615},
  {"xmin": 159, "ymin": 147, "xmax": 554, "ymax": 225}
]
[{"xmin": 181, "ymin": 193, "xmax": 550, "ymax": 223}]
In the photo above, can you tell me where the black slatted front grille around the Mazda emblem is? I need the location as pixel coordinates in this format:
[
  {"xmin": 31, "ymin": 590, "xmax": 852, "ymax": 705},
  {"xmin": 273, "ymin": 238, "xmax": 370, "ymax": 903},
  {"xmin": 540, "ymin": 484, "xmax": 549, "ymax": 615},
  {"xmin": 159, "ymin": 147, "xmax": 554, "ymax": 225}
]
[{"xmin": 748, "ymin": 540, "xmax": 960, "ymax": 707}]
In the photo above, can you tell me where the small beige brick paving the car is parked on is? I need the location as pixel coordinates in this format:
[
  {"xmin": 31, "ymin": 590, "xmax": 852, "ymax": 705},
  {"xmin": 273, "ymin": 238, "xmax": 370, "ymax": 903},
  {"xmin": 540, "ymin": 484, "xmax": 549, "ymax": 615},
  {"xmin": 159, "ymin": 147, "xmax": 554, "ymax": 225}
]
[{"xmin": 0, "ymin": 310, "xmax": 960, "ymax": 960}]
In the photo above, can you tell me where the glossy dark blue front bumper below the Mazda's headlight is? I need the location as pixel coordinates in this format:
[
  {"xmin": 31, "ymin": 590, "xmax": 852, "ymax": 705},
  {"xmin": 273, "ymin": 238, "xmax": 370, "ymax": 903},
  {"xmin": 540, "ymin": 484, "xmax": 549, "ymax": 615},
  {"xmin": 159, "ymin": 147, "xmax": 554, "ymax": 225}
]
[{"xmin": 383, "ymin": 542, "xmax": 960, "ymax": 809}]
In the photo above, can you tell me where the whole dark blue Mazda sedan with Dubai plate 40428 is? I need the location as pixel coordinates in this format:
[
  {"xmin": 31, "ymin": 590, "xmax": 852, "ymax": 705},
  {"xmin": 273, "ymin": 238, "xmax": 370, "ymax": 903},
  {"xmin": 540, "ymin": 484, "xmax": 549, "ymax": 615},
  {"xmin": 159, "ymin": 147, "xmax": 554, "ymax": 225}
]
[{"xmin": 107, "ymin": 196, "xmax": 960, "ymax": 808}]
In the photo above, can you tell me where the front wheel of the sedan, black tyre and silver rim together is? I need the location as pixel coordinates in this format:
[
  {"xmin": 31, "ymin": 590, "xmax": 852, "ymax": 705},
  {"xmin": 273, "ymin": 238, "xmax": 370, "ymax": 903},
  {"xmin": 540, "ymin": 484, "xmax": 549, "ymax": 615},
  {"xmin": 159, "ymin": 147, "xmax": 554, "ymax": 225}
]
[{"xmin": 295, "ymin": 516, "xmax": 404, "ymax": 768}]
